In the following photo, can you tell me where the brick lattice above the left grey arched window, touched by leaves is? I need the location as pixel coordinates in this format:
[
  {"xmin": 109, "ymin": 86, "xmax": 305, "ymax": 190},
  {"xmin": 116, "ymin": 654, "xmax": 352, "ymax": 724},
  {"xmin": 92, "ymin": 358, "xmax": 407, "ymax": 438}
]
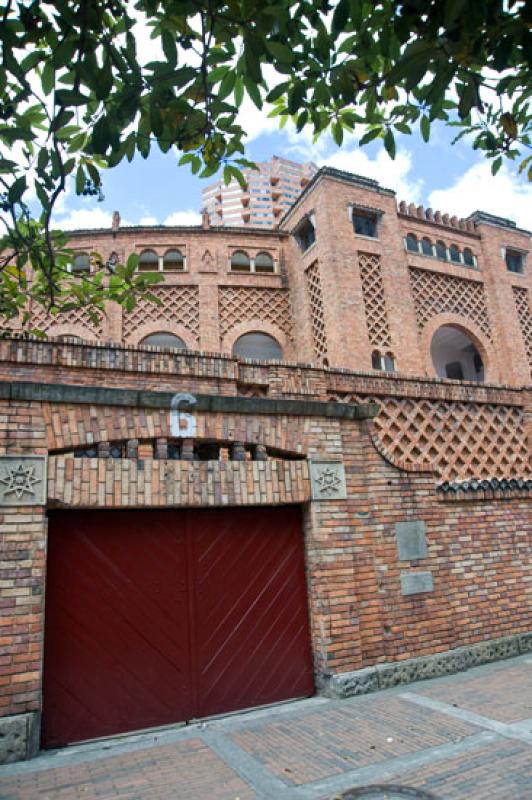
[{"xmin": 124, "ymin": 286, "xmax": 199, "ymax": 341}]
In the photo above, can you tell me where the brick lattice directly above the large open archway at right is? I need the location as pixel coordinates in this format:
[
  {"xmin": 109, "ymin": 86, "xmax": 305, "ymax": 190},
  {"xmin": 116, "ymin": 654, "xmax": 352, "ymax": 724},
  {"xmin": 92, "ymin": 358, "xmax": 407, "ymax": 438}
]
[{"xmin": 410, "ymin": 268, "xmax": 491, "ymax": 338}]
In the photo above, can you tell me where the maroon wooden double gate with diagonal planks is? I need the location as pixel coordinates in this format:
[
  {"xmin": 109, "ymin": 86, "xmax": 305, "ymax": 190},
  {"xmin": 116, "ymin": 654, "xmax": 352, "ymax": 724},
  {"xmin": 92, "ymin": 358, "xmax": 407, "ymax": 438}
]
[{"xmin": 43, "ymin": 507, "xmax": 313, "ymax": 747}]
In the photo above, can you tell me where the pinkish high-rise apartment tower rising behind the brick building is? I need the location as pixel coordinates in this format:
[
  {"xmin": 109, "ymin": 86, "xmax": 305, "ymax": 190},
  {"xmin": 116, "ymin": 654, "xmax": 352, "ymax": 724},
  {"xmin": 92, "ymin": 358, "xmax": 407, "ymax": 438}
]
[{"xmin": 202, "ymin": 156, "xmax": 318, "ymax": 228}]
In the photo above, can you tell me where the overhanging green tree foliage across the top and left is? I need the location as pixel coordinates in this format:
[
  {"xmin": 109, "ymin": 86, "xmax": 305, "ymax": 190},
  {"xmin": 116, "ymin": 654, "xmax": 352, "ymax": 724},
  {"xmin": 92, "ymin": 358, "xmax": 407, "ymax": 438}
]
[{"xmin": 0, "ymin": 0, "xmax": 532, "ymax": 324}]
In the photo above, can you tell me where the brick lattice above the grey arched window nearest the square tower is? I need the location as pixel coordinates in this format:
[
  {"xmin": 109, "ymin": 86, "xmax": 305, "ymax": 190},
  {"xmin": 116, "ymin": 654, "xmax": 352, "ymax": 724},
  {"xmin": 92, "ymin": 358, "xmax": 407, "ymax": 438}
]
[{"xmin": 219, "ymin": 286, "xmax": 292, "ymax": 338}]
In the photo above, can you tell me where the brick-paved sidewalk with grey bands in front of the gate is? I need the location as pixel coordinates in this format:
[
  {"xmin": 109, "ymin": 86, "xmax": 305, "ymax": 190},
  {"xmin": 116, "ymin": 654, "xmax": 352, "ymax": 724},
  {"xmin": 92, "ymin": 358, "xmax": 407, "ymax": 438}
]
[{"xmin": 0, "ymin": 656, "xmax": 532, "ymax": 800}]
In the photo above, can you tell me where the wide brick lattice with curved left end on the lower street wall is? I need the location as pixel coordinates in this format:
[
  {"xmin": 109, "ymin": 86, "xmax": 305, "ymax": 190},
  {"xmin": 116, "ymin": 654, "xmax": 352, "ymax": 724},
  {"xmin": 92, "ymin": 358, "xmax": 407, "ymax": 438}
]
[{"xmin": 331, "ymin": 395, "xmax": 530, "ymax": 481}]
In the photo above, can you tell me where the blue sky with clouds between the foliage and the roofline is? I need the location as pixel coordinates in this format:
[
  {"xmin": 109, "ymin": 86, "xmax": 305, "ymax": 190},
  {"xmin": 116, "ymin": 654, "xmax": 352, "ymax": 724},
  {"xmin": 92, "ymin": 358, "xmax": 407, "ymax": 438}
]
[{"xmin": 55, "ymin": 108, "xmax": 532, "ymax": 229}]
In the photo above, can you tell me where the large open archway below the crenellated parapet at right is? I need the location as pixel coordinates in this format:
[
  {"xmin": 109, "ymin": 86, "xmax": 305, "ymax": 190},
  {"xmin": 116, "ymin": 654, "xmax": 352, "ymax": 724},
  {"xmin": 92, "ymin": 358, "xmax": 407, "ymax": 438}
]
[{"xmin": 430, "ymin": 325, "xmax": 484, "ymax": 383}]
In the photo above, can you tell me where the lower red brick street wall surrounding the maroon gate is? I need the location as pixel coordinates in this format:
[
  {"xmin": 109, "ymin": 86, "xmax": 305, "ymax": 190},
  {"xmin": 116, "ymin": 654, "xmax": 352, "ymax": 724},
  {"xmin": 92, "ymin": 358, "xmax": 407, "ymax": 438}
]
[{"xmin": 0, "ymin": 342, "xmax": 531, "ymax": 714}]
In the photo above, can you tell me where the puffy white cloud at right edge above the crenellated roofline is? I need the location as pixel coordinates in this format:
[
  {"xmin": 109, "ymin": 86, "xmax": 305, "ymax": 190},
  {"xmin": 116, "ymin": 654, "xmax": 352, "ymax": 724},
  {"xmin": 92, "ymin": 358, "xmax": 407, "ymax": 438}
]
[{"xmin": 429, "ymin": 161, "xmax": 532, "ymax": 228}]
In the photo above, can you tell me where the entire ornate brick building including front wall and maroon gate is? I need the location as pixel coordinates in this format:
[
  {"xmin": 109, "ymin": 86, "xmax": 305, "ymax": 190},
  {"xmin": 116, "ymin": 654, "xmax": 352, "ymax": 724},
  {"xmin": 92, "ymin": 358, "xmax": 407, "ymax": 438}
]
[{"xmin": 0, "ymin": 169, "xmax": 532, "ymax": 760}]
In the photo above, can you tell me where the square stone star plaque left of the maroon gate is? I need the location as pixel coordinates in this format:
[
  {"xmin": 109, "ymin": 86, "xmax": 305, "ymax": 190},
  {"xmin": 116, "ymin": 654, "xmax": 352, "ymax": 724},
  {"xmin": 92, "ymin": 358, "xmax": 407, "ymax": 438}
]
[{"xmin": 0, "ymin": 456, "xmax": 47, "ymax": 506}]
